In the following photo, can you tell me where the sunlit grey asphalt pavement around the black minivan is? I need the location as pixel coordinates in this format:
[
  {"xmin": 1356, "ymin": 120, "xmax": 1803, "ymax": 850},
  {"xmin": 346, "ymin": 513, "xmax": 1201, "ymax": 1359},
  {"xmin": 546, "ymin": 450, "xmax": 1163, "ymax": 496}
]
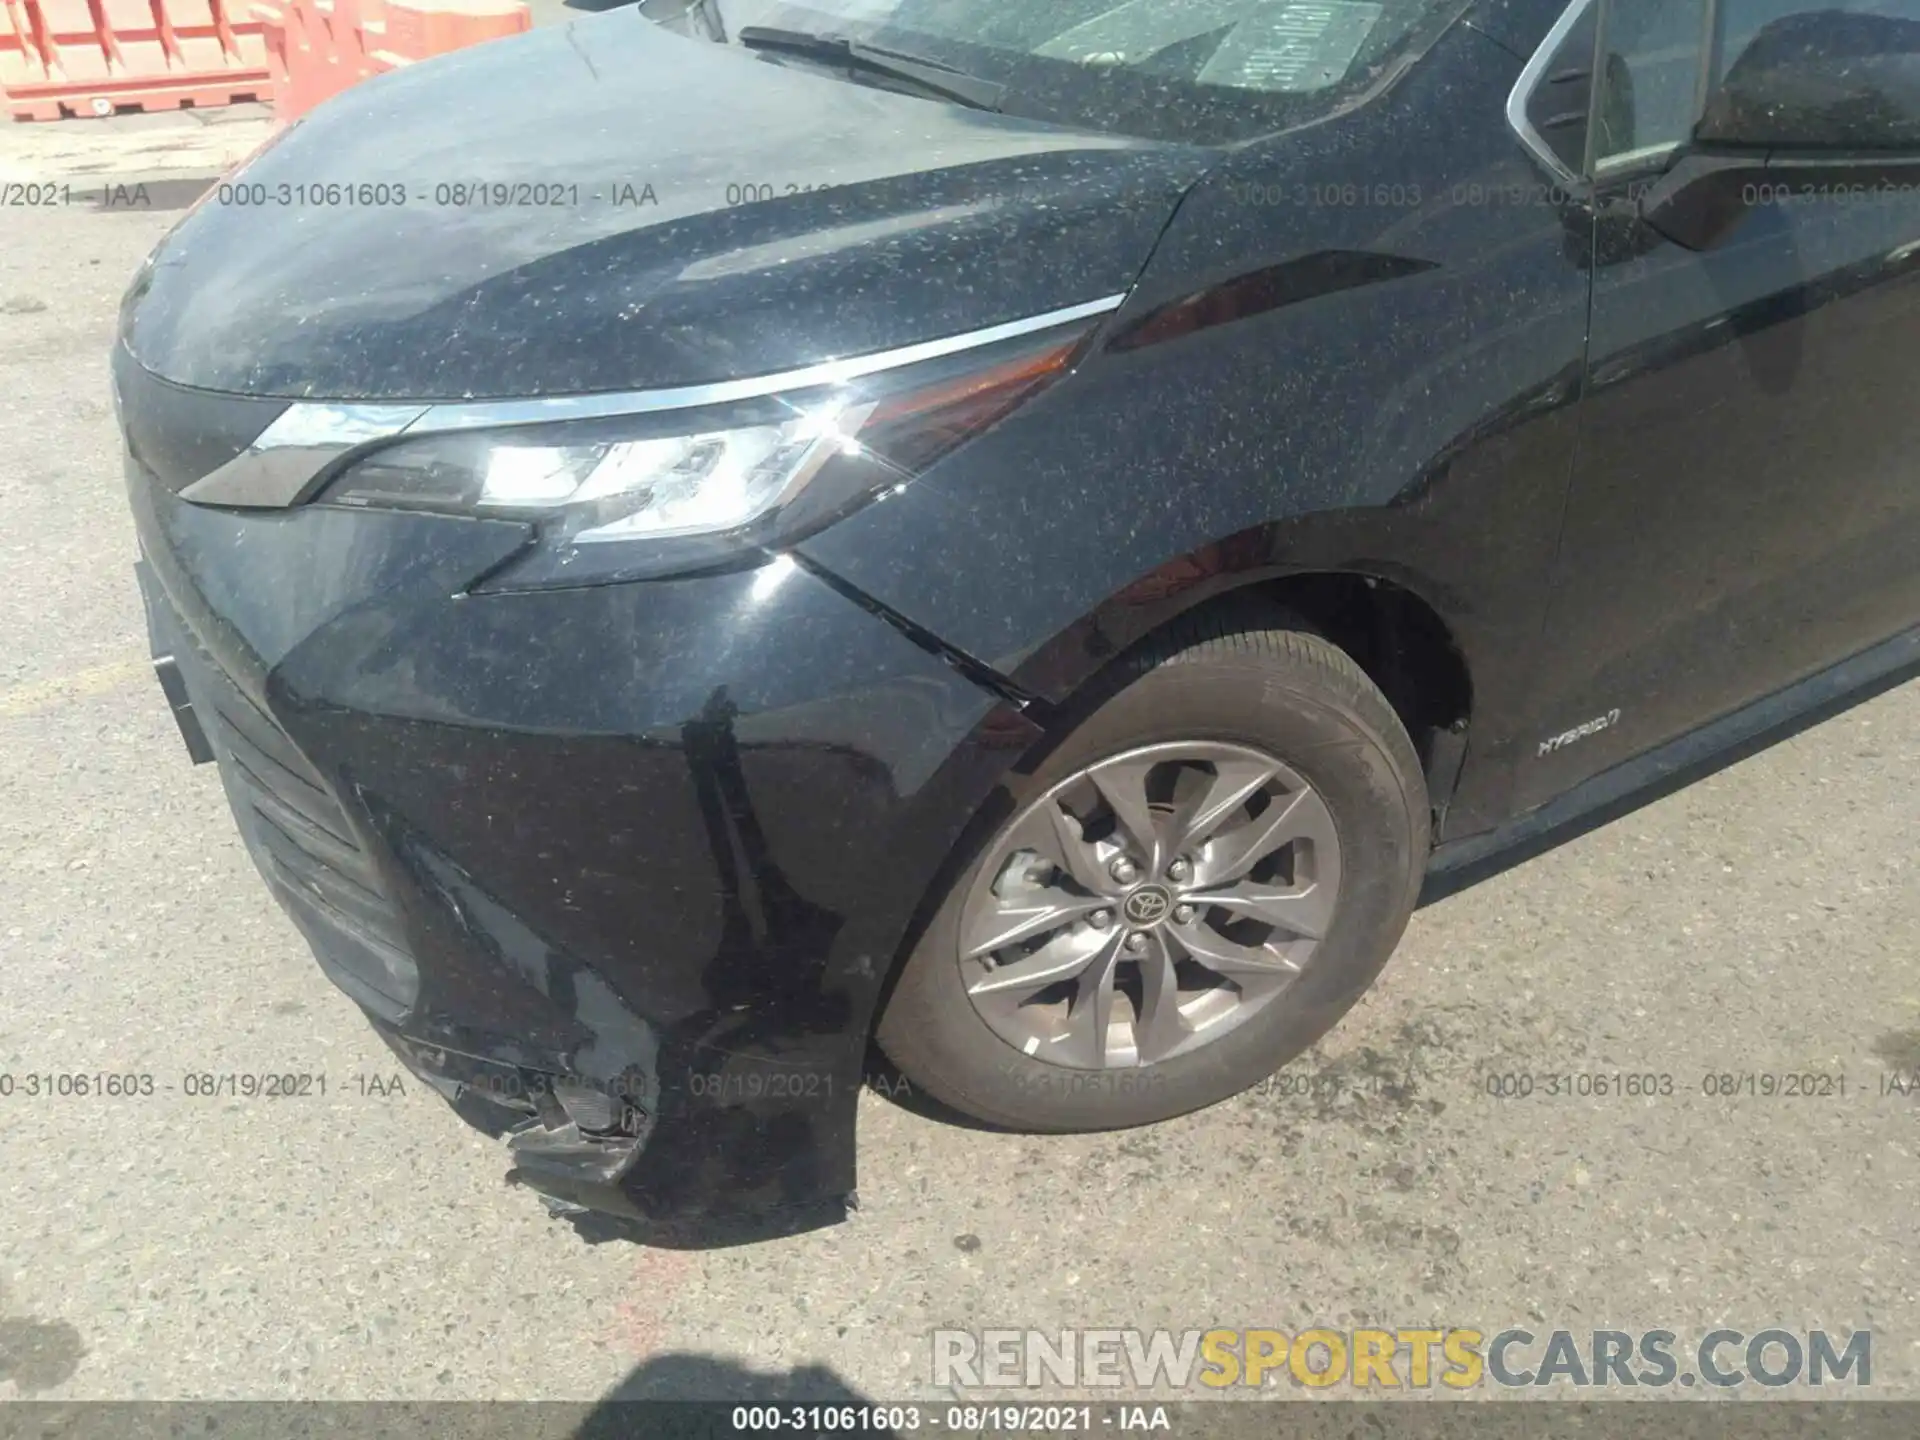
[{"xmin": 0, "ymin": 186, "xmax": 1920, "ymax": 1400}]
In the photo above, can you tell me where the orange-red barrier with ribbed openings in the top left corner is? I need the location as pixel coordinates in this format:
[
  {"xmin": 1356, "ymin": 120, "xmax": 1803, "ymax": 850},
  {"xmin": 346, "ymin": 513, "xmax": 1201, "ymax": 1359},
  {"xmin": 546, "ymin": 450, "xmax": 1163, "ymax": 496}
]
[{"xmin": 0, "ymin": 0, "xmax": 273, "ymax": 119}]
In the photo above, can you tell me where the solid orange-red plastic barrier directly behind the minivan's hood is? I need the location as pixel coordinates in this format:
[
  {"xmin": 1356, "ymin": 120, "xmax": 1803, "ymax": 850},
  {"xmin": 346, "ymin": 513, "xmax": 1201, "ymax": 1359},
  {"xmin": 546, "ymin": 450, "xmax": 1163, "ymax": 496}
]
[{"xmin": 255, "ymin": 0, "xmax": 534, "ymax": 121}]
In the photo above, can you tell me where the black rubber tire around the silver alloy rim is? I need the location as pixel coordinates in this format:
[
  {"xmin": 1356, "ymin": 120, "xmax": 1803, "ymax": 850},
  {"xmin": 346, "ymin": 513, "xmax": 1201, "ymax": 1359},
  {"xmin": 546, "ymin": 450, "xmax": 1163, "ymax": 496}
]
[{"xmin": 877, "ymin": 612, "xmax": 1430, "ymax": 1133}]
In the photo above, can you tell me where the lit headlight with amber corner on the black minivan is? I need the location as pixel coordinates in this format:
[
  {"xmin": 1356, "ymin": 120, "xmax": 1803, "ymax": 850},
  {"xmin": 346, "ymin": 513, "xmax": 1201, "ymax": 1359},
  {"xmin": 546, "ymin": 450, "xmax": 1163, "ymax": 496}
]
[{"xmin": 319, "ymin": 324, "xmax": 1087, "ymax": 588}]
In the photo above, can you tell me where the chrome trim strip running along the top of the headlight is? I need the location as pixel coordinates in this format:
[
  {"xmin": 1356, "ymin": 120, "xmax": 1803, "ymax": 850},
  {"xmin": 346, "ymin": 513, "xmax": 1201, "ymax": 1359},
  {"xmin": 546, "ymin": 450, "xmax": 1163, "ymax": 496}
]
[{"xmin": 180, "ymin": 294, "xmax": 1127, "ymax": 509}]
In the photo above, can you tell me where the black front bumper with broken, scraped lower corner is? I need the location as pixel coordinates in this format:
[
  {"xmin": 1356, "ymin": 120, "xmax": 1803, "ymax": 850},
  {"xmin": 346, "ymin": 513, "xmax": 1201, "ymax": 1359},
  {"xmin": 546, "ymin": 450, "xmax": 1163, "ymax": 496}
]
[{"xmin": 129, "ymin": 445, "xmax": 1033, "ymax": 1246}]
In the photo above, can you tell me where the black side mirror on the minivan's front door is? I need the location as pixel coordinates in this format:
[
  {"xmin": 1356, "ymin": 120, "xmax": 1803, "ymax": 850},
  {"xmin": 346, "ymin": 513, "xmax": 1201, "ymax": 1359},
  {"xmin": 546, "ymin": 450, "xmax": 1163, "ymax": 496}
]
[{"xmin": 1640, "ymin": 10, "xmax": 1920, "ymax": 250}]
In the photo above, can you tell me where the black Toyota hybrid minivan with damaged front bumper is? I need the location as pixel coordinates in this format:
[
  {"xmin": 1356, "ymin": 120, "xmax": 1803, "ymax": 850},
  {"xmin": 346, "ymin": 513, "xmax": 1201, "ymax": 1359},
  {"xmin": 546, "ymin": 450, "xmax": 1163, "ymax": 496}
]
[{"xmin": 113, "ymin": 0, "xmax": 1920, "ymax": 1242}]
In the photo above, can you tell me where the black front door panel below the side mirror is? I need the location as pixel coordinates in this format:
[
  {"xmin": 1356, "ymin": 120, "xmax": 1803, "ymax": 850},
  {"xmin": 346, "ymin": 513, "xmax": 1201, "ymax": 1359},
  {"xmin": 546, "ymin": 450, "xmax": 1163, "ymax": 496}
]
[{"xmin": 1517, "ymin": 0, "xmax": 1920, "ymax": 804}]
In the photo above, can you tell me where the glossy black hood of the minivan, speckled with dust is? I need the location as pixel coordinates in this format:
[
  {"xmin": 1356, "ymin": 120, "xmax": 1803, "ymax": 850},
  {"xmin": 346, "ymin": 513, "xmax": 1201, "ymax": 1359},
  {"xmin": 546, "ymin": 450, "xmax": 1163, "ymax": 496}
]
[{"xmin": 123, "ymin": 10, "xmax": 1217, "ymax": 399}]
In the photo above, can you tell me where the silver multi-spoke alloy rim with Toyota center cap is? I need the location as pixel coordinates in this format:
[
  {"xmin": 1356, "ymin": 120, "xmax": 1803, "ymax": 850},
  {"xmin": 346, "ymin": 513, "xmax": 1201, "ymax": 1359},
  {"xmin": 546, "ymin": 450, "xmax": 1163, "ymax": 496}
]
[{"xmin": 960, "ymin": 741, "xmax": 1340, "ymax": 1069}]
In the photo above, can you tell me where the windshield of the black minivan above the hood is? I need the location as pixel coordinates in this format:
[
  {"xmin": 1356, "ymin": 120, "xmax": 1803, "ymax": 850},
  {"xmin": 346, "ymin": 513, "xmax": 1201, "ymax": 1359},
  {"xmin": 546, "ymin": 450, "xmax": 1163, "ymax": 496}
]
[{"xmin": 687, "ymin": 0, "xmax": 1467, "ymax": 144}]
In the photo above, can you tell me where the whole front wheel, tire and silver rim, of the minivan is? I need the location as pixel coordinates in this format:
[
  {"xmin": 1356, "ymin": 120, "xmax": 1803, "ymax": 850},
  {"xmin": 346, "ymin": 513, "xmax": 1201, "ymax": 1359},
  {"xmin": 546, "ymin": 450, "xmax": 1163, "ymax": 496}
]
[{"xmin": 879, "ymin": 624, "xmax": 1428, "ymax": 1131}]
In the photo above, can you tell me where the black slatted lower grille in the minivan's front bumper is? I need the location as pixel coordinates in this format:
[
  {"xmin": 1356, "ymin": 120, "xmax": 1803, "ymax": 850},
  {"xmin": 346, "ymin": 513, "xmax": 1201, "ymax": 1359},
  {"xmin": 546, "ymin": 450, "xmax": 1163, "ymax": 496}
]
[{"xmin": 148, "ymin": 568, "xmax": 419, "ymax": 1021}]
